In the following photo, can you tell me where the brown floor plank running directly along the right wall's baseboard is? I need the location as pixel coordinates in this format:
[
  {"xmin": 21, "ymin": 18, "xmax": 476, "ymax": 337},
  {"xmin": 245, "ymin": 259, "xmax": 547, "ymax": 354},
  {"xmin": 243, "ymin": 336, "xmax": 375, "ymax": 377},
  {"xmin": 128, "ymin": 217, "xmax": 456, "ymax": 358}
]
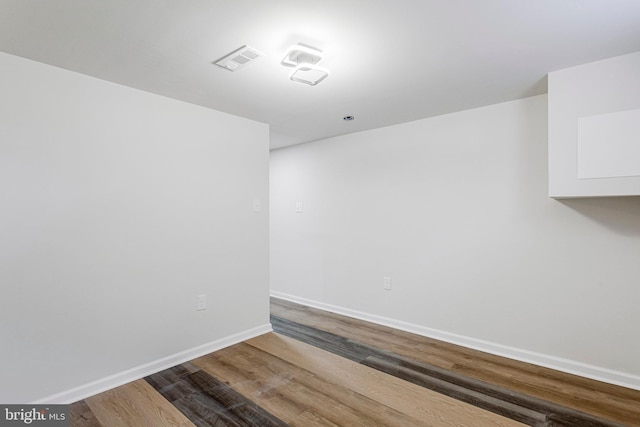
[{"xmin": 271, "ymin": 298, "xmax": 640, "ymax": 426}]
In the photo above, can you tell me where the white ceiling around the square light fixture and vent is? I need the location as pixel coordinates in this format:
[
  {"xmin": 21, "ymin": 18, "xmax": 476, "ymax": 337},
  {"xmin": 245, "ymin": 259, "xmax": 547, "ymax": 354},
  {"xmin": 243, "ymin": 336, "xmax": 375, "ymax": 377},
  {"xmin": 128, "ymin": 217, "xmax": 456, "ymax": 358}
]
[{"xmin": 0, "ymin": 0, "xmax": 640, "ymax": 148}]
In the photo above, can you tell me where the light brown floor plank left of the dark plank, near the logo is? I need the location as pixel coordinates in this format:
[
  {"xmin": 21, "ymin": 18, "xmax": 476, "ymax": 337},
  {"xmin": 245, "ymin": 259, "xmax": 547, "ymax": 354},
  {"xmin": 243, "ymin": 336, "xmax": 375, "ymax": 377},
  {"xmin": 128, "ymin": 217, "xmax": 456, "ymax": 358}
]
[{"xmin": 85, "ymin": 380, "xmax": 195, "ymax": 427}]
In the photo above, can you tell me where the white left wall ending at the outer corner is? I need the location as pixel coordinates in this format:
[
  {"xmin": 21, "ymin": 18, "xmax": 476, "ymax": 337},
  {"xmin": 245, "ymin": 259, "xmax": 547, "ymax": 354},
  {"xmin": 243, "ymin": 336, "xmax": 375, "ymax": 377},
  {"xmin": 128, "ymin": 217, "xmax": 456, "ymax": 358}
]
[{"xmin": 0, "ymin": 53, "xmax": 269, "ymax": 403}]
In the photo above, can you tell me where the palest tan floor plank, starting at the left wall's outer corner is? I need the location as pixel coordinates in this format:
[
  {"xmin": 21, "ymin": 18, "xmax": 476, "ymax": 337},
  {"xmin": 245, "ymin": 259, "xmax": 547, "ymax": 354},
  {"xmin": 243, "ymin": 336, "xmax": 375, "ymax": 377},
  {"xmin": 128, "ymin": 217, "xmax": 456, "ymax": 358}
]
[{"xmin": 247, "ymin": 333, "xmax": 522, "ymax": 426}]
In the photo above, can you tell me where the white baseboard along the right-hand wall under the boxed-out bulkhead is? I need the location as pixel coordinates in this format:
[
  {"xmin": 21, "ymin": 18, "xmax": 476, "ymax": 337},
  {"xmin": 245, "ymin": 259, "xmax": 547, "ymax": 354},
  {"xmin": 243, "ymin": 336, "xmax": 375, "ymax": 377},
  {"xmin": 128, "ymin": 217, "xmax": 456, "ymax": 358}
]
[{"xmin": 271, "ymin": 291, "xmax": 640, "ymax": 390}]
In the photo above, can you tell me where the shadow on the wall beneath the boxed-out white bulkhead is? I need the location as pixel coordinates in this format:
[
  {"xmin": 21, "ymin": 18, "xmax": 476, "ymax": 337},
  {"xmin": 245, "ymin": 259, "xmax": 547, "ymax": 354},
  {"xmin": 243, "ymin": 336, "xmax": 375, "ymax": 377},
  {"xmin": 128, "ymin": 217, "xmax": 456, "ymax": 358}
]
[{"xmin": 558, "ymin": 196, "xmax": 640, "ymax": 236}]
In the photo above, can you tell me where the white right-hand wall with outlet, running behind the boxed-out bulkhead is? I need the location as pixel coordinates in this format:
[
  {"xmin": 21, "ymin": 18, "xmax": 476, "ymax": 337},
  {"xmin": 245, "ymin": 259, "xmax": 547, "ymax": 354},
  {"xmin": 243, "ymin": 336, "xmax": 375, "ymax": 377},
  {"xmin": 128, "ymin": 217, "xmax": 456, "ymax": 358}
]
[{"xmin": 270, "ymin": 95, "xmax": 640, "ymax": 388}]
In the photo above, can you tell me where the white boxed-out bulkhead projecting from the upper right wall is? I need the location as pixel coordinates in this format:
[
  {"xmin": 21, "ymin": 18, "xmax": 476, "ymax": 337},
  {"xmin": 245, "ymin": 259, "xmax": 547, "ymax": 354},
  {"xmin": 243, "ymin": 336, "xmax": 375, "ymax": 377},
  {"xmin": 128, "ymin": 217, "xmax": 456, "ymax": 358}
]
[{"xmin": 549, "ymin": 52, "xmax": 640, "ymax": 197}]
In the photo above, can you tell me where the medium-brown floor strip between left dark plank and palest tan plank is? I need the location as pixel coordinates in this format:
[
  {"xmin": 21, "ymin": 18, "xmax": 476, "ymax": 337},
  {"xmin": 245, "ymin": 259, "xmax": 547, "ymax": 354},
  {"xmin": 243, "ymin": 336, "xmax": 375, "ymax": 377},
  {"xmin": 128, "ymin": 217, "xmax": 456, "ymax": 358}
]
[{"xmin": 194, "ymin": 344, "xmax": 460, "ymax": 426}]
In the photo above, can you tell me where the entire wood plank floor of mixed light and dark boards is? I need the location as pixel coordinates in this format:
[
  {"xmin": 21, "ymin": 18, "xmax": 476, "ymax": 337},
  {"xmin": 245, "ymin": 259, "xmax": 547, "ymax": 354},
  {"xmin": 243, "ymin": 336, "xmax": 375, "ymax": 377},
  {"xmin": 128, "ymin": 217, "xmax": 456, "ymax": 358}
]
[{"xmin": 71, "ymin": 299, "xmax": 640, "ymax": 427}]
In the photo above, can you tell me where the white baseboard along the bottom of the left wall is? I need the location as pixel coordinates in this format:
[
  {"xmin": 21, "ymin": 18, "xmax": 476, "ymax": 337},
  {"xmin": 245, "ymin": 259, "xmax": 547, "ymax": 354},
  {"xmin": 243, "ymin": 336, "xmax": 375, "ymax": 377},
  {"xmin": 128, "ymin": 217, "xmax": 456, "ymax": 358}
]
[{"xmin": 32, "ymin": 323, "xmax": 273, "ymax": 404}]
